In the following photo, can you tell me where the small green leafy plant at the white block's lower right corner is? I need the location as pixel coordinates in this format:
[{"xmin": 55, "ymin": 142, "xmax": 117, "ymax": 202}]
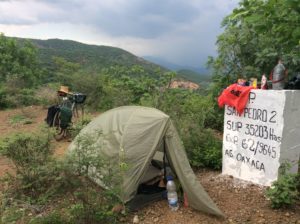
[{"xmin": 266, "ymin": 163, "xmax": 300, "ymax": 209}]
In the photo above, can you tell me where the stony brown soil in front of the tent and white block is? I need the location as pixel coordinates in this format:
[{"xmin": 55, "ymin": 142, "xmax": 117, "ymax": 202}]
[{"xmin": 126, "ymin": 170, "xmax": 300, "ymax": 224}]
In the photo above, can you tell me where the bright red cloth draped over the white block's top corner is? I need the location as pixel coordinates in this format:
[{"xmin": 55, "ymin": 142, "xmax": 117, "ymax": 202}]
[{"xmin": 218, "ymin": 84, "xmax": 253, "ymax": 115}]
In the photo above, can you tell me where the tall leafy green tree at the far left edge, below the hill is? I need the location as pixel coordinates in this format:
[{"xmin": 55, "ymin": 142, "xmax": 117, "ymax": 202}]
[{"xmin": 0, "ymin": 34, "xmax": 40, "ymax": 107}]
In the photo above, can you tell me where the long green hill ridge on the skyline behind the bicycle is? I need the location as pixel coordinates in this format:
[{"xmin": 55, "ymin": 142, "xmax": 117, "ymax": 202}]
[{"xmin": 16, "ymin": 38, "xmax": 167, "ymax": 76}]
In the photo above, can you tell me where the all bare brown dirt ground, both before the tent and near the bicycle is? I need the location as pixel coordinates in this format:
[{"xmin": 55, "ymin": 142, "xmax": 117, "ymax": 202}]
[{"xmin": 0, "ymin": 106, "xmax": 300, "ymax": 224}]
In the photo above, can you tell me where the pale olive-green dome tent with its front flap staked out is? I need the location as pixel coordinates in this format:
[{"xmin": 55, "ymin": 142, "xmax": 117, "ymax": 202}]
[{"xmin": 68, "ymin": 106, "xmax": 223, "ymax": 216}]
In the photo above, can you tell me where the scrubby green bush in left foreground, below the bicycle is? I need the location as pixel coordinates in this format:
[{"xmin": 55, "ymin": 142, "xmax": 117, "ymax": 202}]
[{"xmin": 0, "ymin": 130, "xmax": 60, "ymax": 199}]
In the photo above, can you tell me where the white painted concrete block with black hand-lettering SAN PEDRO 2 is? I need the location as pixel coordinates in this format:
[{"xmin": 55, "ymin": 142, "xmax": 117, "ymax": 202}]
[{"xmin": 222, "ymin": 90, "xmax": 300, "ymax": 186}]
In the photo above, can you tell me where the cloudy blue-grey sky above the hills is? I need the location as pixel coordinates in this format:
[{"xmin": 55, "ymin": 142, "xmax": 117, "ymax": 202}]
[{"xmin": 0, "ymin": 0, "xmax": 239, "ymax": 67}]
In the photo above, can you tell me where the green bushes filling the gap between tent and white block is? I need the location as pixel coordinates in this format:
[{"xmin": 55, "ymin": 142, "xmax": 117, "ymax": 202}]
[{"xmin": 142, "ymin": 89, "xmax": 222, "ymax": 169}]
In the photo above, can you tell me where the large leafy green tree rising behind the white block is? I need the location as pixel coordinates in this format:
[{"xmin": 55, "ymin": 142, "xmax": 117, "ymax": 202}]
[{"xmin": 208, "ymin": 0, "xmax": 300, "ymax": 89}]
